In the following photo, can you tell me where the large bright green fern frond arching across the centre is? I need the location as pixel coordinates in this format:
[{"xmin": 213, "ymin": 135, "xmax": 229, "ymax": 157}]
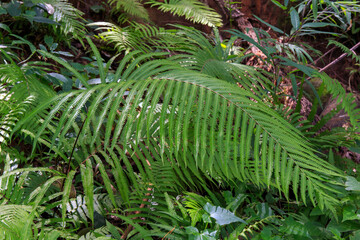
[{"xmin": 16, "ymin": 66, "xmax": 342, "ymax": 214}]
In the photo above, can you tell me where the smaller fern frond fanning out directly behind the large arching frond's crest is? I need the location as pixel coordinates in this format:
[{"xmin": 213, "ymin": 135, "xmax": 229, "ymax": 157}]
[{"xmin": 171, "ymin": 25, "xmax": 274, "ymax": 99}]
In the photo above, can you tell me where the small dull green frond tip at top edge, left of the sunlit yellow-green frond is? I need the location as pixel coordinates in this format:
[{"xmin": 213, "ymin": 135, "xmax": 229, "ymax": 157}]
[{"xmin": 108, "ymin": 0, "xmax": 149, "ymax": 21}]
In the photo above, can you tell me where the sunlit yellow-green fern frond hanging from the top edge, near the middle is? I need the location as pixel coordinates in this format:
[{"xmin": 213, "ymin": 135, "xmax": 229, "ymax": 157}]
[{"xmin": 149, "ymin": 0, "xmax": 222, "ymax": 27}]
